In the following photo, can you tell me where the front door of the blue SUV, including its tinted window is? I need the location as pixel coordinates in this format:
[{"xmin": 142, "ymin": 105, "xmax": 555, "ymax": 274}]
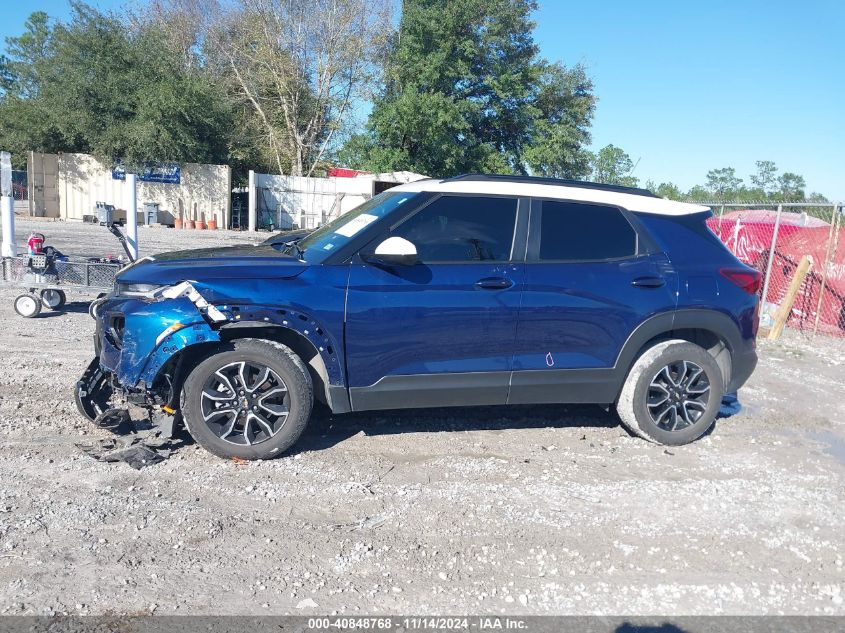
[{"xmin": 346, "ymin": 195, "xmax": 527, "ymax": 410}]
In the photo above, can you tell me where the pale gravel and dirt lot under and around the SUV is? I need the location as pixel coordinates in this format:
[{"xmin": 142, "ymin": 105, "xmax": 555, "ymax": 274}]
[{"xmin": 0, "ymin": 220, "xmax": 845, "ymax": 615}]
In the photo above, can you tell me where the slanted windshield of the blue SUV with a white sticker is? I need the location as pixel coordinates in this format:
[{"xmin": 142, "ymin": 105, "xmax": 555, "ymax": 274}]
[{"xmin": 293, "ymin": 191, "xmax": 417, "ymax": 264}]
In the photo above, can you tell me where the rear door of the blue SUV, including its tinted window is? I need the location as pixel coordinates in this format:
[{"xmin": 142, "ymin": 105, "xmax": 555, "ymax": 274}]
[{"xmin": 509, "ymin": 200, "xmax": 677, "ymax": 403}]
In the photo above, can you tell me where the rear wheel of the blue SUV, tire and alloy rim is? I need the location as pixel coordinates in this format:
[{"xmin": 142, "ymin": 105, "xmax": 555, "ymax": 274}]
[{"xmin": 616, "ymin": 339, "xmax": 725, "ymax": 446}]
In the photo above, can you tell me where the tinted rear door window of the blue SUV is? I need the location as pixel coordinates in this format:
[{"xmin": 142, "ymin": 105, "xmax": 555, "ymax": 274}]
[{"xmin": 540, "ymin": 200, "xmax": 637, "ymax": 261}]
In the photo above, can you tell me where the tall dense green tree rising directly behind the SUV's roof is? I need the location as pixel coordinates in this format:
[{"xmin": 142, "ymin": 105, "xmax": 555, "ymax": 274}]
[{"xmin": 340, "ymin": 0, "xmax": 595, "ymax": 177}]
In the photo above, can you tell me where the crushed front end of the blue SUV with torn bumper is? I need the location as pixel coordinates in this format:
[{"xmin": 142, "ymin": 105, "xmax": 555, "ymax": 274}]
[{"xmin": 75, "ymin": 281, "xmax": 226, "ymax": 436}]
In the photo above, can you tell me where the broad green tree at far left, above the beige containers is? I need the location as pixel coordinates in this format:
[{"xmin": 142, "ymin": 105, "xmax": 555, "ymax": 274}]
[{"xmin": 0, "ymin": 2, "xmax": 232, "ymax": 168}]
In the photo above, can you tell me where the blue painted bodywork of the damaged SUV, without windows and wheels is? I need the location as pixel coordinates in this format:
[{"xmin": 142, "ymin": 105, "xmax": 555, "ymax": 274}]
[{"xmin": 85, "ymin": 181, "xmax": 758, "ymax": 428}]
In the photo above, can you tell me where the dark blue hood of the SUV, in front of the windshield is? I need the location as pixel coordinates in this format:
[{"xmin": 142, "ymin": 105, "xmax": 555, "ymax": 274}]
[{"xmin": 117, "ymin": 244, "xmax": 308, "ymax": 285}]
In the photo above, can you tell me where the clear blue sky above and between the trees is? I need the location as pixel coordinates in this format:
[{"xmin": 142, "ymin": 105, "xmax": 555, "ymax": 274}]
[{"xmin": 0, "ymin": 0, "xmax": 845, "ymax": 200}]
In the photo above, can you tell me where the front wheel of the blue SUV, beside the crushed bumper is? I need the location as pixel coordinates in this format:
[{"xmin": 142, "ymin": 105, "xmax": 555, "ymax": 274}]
[{"xmin": 181, "ymin": 339, "xmax": 314, "ymax": 460}]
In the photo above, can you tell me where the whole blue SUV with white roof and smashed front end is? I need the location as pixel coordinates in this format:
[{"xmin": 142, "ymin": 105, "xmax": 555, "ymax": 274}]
[{"xmin": 76, "ymin": 175, "xmax": 760, "ymax": 459}]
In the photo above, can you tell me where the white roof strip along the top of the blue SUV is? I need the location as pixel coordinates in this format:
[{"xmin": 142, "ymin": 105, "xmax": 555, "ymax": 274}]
[{"xmin": 390, "ymin": 180, "xmax": 710, "ymax": 215}]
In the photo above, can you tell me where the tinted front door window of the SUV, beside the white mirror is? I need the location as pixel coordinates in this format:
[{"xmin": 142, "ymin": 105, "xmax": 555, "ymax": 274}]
[{"xmin": 391, "ymin": 196, "xmax": 517, "ymax": 263}]
